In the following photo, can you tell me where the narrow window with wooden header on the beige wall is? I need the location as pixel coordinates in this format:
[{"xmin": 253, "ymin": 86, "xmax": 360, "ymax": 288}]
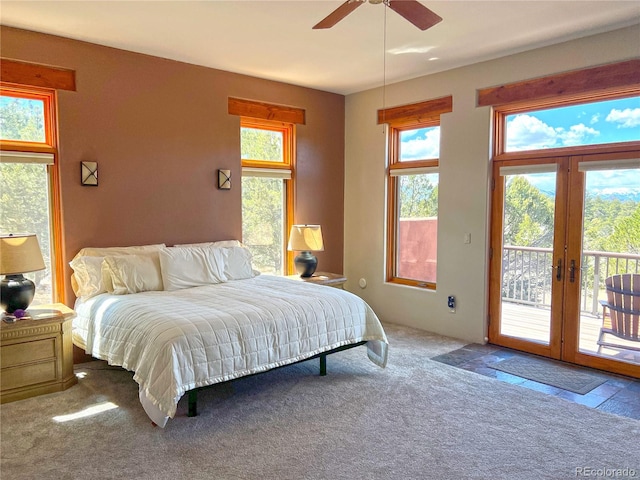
[{"xmin": 378, "ymin": 96, "xmax": 453, "ymax": 290}]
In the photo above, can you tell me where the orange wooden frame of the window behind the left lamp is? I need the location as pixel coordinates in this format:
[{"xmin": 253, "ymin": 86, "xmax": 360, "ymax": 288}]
[{"xmin": 0, "ymin": 84, "xmax": 65, "ymax": 303}]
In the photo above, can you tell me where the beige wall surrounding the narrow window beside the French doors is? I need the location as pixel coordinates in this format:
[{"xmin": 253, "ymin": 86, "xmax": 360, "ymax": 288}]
[{"xmin": 344, "ymin": 26, "xmax": 640, "ymax": 342}]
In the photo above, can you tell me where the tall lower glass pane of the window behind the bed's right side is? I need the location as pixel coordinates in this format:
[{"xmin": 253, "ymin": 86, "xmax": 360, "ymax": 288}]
[{"xmin": 242, "ymin": 176, "xmax": 286, "ymax": 275}]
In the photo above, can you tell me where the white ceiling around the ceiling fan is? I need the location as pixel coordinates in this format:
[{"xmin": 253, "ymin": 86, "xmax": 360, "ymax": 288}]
[{"xmin": 0, "ymin": 0, "xmax": 640, "ymax": 94}]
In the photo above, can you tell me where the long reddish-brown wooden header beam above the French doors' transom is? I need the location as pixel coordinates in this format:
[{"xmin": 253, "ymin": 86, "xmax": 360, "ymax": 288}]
[{"xmin": 477, "ymin": 58, "xmax": 640, "ymax": 107}]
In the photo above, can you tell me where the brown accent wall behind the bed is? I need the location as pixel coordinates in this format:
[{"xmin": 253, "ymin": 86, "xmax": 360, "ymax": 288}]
[{"xmin": 0, "ymin": 26, "xmax": 345, "ymax": 305}]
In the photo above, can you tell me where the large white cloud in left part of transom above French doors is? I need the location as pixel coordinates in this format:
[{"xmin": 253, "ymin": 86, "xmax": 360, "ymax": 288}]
[{"xmin": 507, "ymin": 114, "xmax": 600, "ymax": 152}]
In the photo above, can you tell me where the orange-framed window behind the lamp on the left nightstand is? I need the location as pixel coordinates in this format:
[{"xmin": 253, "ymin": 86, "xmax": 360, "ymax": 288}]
[{"xmin": 0, "ymin": 86, "xmax": 63, "ymax": 304}]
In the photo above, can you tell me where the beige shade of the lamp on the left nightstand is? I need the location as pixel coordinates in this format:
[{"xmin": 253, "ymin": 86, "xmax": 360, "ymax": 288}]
[{"xmin": 0, "ymin": 233, "xmax": 45, "ymax": 275}]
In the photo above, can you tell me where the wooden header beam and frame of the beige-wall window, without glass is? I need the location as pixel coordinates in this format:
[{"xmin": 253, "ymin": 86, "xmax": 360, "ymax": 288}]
[{"xmin": 378, "ymin": 96, "xmax": 453, "ymax": 290}]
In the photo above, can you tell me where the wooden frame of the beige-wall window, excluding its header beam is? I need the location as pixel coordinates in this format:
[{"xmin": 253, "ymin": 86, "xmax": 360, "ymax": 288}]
[{"xmin": 385, "ymin": 119, "xmax": 441, "ymax": 290}]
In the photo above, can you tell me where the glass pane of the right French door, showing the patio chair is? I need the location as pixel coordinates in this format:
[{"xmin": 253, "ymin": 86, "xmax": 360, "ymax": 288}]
[{"xmin": 579, "ymin": 167, "xmax": 640, "ymax": 364}]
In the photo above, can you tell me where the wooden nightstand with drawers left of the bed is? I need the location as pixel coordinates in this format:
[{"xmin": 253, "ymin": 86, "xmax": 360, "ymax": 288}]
[{"xmin": 0, "ymin": 303, "xmax": 78, "ymax": 403}]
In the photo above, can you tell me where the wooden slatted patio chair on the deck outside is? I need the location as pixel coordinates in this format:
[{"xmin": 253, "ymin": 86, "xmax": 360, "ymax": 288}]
[{"xmin": 598, "ymin": 273, "xmax": 640, "ymax": 353}]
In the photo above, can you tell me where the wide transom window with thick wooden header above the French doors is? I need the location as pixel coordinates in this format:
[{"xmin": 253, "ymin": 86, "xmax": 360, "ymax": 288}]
[{"xmin": 477, "ymin": 59, "xmax": 640, "ymax": 161}]
